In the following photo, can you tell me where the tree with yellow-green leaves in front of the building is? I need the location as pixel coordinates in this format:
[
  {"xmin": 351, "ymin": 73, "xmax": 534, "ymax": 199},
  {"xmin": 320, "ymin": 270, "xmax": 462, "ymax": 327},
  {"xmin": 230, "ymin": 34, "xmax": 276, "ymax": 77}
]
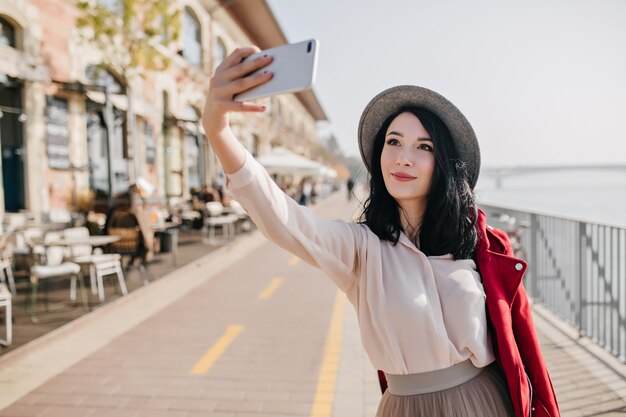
[{"xmin": 74, "ymin": 0, "xmax": 181, "ymax": 196}]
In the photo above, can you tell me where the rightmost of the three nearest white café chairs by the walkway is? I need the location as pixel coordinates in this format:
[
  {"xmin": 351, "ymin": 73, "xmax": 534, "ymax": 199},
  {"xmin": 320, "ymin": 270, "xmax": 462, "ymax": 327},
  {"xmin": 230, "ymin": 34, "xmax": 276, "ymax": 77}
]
[{"xmin": 63, "ymin": 227, "xmax": 128, "ymax": 302}]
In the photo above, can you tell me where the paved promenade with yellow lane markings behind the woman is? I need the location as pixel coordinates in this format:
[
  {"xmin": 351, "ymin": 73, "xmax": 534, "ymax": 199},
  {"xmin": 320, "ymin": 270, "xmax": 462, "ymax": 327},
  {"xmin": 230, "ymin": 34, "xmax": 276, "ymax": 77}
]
[{"xmin": 0, "ymin": 194, "xmax": 626, "ymax": 417}]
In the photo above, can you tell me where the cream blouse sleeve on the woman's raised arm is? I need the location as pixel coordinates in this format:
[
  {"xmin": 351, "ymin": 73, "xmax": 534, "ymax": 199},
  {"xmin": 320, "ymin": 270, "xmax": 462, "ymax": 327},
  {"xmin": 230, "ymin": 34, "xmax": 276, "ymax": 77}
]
[{"xmin": 228, "ymin": 153, "xmax": 367, "ymax": 292}]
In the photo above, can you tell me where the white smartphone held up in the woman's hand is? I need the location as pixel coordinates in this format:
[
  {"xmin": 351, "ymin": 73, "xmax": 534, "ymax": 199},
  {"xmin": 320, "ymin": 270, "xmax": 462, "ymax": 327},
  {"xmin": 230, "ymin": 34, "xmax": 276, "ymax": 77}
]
[{"xmin": 234, "ymin": 39, "xmax": 319, "ymax": 101}]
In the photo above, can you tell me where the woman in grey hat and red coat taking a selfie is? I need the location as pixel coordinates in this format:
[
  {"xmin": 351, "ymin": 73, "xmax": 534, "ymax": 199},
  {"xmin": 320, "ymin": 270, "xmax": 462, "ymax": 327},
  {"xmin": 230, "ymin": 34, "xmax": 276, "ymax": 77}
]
[{"xmin": 203, "ymin": 48, "xmax": 559, "ymax": 417}]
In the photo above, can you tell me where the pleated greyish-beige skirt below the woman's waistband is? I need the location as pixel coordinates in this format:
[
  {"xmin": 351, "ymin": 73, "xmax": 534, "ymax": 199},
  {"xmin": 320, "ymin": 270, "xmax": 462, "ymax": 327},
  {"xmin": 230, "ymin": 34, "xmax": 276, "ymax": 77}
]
[{"xmin": 376, "ymin": 362, "xmax": 515, "ymax": 417}]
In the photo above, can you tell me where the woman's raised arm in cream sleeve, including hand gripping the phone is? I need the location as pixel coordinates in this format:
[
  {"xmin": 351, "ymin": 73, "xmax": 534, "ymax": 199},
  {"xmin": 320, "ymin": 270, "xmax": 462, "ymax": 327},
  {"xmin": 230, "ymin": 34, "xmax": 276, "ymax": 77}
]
[{"xmin": 202, "ymin": 47, "xmax": 367, "ymax": 291}]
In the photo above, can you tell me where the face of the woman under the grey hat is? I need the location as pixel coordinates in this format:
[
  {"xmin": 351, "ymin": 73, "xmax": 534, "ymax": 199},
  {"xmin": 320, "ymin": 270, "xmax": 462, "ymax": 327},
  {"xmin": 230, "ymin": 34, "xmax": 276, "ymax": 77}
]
[{"xmin": 380, "ymin": 112, "xmax": 435, "ymax": 208}]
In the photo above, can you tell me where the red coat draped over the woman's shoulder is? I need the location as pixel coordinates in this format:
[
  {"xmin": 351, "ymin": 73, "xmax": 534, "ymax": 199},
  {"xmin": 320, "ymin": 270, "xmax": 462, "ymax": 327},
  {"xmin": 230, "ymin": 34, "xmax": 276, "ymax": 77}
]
[{"xmin": 378, "ymin": 210, "xmax": 561, "ymax": 417}]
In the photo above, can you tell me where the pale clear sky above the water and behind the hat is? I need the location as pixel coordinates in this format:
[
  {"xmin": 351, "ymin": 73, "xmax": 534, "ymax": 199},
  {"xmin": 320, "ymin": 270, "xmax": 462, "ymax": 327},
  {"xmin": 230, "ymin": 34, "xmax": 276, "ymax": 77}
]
[{"xmin": 268, "ymin": 0, "xmax": 626, "ymax": 167}]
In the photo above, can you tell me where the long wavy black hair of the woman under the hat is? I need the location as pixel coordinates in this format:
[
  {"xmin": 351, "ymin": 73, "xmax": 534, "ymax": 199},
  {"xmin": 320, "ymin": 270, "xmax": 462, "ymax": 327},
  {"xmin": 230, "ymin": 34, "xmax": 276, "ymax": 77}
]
[{"xmin": 360, "ymin": 107, "xmax": 477, "ymax": 259}]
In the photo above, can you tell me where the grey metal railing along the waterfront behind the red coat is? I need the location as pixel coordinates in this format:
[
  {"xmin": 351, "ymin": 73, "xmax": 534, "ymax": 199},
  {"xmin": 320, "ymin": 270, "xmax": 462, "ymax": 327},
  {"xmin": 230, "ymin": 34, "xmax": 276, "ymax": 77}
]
[{"xmin": 480, "ymin": 205, "xmax": 626, "ymax": 362}]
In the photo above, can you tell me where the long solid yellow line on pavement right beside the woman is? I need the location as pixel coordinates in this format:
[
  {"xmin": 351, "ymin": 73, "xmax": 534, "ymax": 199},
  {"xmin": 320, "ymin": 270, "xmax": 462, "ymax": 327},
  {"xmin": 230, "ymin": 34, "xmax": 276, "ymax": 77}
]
[{"xmin": 311, "ymin": 292, "xmax": 346, "ymax": 417}]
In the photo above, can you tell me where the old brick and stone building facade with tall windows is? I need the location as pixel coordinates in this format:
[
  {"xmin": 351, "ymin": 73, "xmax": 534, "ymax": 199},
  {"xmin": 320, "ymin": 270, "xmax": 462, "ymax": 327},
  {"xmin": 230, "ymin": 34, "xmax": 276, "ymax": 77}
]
[{"xmin": 0, "ymin": 0, "xmax": 326, "ymax": 216}]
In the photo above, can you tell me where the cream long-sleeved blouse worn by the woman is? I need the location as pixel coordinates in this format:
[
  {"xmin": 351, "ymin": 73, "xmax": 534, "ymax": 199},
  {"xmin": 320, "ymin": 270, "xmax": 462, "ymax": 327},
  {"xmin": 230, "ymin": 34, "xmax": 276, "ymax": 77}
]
[{"xmin": 228, "ymin": 153, "xmax": 494, "ymax": 374}]
